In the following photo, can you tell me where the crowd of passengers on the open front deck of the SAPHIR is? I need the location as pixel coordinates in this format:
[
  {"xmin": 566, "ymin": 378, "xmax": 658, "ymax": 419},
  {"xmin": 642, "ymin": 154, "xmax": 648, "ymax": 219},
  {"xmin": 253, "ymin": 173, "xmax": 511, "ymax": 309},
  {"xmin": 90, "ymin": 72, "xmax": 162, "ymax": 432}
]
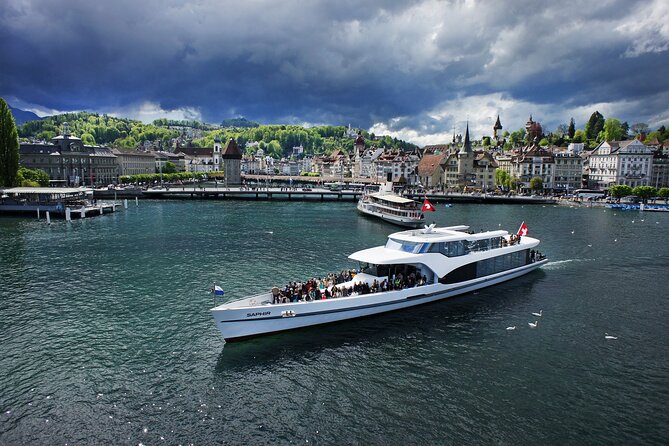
[{"xmin": 272, "ymin": 270, "xmax": 427, "ymax": 304}]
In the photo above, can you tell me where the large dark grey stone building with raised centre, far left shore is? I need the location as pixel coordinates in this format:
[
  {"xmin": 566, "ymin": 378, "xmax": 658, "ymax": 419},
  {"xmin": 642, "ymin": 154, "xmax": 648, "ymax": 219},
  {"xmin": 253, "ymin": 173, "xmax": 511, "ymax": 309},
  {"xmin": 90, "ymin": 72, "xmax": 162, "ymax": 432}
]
[{"xmin": 19, "ymin": 123, "xmax": 119, "ymax": 186}]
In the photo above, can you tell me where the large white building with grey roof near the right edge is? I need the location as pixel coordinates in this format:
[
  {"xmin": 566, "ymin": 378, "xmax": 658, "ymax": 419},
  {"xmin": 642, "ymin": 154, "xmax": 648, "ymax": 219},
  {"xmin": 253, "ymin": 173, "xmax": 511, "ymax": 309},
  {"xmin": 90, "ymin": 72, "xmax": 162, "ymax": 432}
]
[{"xmin": 589, "ymin": 139, "xmax": 653, "ymax": 189}]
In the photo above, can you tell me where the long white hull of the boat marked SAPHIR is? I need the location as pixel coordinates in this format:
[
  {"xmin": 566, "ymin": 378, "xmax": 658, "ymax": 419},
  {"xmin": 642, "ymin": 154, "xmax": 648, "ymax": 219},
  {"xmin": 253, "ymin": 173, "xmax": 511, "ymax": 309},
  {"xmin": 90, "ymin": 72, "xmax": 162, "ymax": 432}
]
[{"xmin": 211, "ymin": 259, "xmax": 547, "ymax": 341}]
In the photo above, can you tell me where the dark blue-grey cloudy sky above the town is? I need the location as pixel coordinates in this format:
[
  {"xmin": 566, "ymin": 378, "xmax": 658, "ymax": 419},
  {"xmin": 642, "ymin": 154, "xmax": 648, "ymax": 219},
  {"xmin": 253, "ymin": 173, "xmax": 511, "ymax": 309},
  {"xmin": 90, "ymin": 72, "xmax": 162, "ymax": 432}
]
[{"xmin": 0, "ymin": 0, "xmax": 669, "ymax": 145}]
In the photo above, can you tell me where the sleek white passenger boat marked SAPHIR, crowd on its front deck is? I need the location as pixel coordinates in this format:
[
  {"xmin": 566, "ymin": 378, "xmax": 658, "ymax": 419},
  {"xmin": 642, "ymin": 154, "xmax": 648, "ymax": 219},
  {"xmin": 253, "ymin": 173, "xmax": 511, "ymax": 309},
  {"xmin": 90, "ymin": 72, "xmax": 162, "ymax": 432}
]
[{"xmin": 211, "ymin": 224, "xmax": 547, "ymax": 341}]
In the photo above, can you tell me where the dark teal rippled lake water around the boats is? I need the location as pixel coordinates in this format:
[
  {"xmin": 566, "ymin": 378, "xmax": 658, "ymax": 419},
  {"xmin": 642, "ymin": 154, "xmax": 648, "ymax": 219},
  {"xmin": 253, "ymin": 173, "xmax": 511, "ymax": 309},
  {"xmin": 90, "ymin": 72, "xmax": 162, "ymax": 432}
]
[{"xmin": 0, "ymin": 201, "xmax": 669, "ymax": 445}]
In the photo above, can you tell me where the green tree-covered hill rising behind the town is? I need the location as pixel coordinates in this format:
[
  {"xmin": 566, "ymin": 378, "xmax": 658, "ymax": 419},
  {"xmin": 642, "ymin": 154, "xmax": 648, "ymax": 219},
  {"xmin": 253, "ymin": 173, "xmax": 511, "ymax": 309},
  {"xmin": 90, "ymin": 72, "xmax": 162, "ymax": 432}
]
[{"xmin": 19, "ymin": 112, "xmax": 417, "ymax": 157}]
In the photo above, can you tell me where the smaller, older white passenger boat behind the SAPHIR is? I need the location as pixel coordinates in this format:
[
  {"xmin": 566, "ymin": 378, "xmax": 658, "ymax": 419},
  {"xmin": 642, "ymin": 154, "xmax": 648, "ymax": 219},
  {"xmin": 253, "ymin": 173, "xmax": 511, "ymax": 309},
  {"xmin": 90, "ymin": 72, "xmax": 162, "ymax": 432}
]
[{"xmin": 358, "ymin": 183, "xmax": 425, "ymax": 228}]
